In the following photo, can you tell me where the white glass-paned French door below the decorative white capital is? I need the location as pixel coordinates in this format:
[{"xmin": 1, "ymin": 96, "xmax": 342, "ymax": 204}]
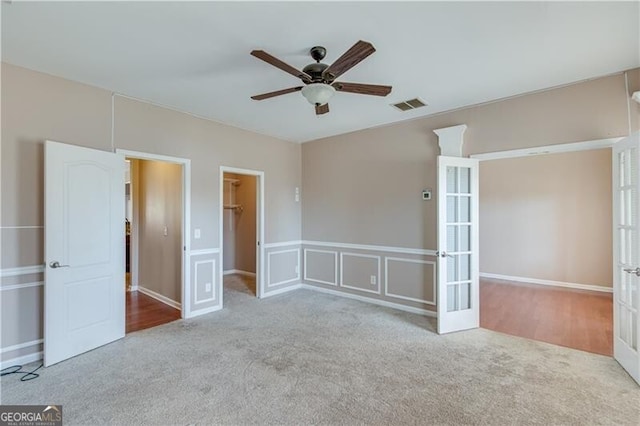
[{"xmin": 437, "ymin": 156, "xmax": 480, "ymax": 334}]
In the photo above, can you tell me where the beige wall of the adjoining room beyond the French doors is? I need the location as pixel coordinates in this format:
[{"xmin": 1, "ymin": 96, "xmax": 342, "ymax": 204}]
[{"xmin": 480, "ymin": 149, "xmax": 613, "ymax": 287}]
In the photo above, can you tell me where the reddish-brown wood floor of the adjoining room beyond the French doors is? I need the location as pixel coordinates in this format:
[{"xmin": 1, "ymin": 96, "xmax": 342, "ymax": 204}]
[{"xmin": 480, "ymin": 278, "xmax": 613, "ymax": 356}]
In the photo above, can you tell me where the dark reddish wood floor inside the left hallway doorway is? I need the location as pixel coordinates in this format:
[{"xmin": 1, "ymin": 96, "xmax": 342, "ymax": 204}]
[{"xmin": 126, "ymin": 291, "xmax": 180, "ymax": 333}]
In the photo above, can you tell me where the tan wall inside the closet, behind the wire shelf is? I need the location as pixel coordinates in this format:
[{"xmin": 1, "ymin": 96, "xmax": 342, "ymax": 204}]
[{"xmin": 224, "ymin": 173, "xmax": 257, "ymax": 274}]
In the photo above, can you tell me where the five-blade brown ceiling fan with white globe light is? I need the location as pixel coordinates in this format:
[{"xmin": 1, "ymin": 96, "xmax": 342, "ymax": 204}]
[{"xmin": 251, "ymin": 40, "xmax": 391, "ymax": 115}]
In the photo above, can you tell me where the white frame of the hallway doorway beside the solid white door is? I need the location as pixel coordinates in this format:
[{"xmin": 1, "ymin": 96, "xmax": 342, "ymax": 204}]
[{"xmin": 116, "ymin": 148, "xmax": 191, "ymax": 318}]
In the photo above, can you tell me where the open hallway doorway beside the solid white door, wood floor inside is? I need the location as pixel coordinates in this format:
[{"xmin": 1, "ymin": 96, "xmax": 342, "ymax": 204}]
[{"xmin": 120, "ymin": 151, "xmax": 185, "ymax": 333}]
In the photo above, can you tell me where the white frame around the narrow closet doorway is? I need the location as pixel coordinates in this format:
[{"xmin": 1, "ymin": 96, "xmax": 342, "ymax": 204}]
[{"xmin": 218, "ymin": 166, "xmax": 265, "ymax": 307}]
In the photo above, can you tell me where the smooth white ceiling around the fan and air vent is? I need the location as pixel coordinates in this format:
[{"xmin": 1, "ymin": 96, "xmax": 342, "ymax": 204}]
[{"xmin": 2, "ymin": 1, "xmax": 640, "ymax": 142}]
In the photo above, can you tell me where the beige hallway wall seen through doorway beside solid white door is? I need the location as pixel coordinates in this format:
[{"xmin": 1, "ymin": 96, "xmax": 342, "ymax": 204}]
[{"xmin": 133, "ymin": 160, "xmax": 182, "ymax": 303}]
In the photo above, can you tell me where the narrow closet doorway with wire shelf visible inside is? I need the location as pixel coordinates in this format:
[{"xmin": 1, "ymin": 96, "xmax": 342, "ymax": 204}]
[{"xmin": 220, "ymin": 167, "xmax": 264, "ymax": 303}]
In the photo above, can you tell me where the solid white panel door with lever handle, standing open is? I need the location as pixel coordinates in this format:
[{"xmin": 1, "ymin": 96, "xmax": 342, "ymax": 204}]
[{"xmin": 44, "ymin": 141, "xmax": 125, "ymax": 366}]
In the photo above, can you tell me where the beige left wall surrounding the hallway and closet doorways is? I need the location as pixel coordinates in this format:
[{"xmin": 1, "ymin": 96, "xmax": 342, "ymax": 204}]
[{"xmin": 0, "ymin": 63, "xmax": 301, "ymax": 359}]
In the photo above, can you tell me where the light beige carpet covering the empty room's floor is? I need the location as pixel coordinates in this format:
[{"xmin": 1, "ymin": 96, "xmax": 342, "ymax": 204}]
[{"xmin": 1, "ymin": 277, "xmax": 640, "ymax": 425}]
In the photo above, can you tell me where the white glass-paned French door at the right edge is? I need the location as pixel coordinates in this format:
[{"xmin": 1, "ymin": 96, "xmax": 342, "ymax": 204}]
[{"xmin": 613, "ymin": 133, "xmax": 640, "ymax": 383}]
